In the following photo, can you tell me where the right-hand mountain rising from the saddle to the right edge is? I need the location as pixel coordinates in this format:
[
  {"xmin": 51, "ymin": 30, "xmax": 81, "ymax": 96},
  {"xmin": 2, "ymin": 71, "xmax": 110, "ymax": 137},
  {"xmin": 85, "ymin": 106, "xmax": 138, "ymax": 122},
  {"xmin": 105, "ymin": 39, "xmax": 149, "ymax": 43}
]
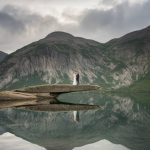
[{"xmin": 106, "ymin": 26, "xmax": 150, "ymax": 92}]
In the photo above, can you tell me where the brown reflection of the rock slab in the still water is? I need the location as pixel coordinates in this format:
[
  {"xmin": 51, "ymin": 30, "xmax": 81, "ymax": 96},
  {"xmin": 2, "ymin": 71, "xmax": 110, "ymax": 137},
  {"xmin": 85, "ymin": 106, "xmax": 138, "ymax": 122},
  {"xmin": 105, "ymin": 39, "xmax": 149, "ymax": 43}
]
[{"xmin": 0, "ymin": 99, "xmax": 100, "ymax": 112}]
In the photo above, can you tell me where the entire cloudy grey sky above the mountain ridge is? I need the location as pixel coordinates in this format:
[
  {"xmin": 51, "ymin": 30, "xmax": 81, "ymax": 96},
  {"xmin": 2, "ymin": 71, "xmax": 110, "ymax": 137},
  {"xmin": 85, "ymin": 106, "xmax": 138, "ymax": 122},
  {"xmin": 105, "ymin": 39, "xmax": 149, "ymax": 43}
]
[{"xmin": 0, "ymin": 0, "xmax": 150, "ymax": 53}]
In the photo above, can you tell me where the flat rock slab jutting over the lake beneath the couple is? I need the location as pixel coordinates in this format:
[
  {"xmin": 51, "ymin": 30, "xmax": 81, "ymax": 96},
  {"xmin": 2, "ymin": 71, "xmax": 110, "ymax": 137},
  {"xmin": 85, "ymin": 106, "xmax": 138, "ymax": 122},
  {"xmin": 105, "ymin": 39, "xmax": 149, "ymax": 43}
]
[{"xmin": 0, "ymin": 84, "xmax": 100, "ymax": 103}]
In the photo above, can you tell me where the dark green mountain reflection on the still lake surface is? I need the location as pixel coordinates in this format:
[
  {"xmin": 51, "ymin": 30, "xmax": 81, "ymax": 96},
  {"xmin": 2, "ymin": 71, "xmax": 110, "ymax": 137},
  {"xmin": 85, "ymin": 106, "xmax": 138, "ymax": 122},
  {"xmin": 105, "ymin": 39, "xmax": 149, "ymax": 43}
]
[{"xmin": 0, "ymin": 92, "xmax": 150, "ymax": 150}]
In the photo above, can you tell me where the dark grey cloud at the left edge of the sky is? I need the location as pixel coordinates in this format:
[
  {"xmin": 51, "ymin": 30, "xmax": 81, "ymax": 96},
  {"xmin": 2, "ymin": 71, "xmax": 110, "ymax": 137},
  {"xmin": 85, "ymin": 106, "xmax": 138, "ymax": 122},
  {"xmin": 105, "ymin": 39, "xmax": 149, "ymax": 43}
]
[{"xmin": 0, "ymin": 5, "xmax": 57, "ymax": 32}]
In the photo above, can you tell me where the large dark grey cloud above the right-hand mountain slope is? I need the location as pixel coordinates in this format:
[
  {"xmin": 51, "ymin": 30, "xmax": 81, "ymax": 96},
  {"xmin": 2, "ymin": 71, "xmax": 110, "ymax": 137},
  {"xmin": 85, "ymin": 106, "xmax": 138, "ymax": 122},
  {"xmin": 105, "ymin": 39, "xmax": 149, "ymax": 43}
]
[{"xmin": 80, "ymin": 1, "xmax": 150, "ymax": 32}]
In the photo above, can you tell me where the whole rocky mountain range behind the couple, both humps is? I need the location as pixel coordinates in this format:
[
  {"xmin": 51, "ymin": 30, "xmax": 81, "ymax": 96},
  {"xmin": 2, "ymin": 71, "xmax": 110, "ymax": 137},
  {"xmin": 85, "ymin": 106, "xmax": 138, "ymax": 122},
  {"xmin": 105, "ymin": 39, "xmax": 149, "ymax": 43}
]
[{"xmin": 0, "ymin": 26, "xmax": 150, "ymax": 89}]
